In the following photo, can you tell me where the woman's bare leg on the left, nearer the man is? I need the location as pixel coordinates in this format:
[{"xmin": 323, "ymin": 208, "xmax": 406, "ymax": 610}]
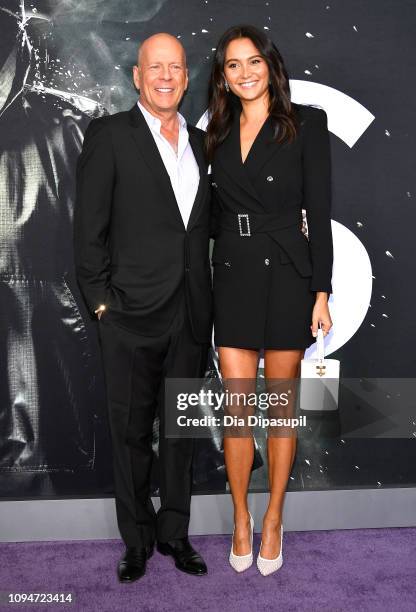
[{"xmin": 218, "ymin": 347, "xmax": 258, "ymax": 555}]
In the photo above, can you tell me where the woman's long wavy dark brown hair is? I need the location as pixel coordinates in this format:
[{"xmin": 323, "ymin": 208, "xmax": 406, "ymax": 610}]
[{"xmin": 206, "ymin": 25, "xmax": 297, "ymax": 161}]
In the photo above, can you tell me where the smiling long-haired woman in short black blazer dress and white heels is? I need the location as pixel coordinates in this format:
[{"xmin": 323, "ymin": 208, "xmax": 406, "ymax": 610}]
[{"xmin": 207, "ymin": 26, "xmax": 333, "ymax": 575}]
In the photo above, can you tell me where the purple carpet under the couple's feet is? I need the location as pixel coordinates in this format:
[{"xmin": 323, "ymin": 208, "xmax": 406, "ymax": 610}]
[{"xmin": 0, "ymin": 528, "xmax": 416, "ymax": 612}]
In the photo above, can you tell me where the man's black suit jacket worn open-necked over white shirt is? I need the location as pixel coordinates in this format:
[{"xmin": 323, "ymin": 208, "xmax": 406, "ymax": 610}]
[{"xmin": 74, "ymin": 104, "xmax": 211, "ymax": 342}]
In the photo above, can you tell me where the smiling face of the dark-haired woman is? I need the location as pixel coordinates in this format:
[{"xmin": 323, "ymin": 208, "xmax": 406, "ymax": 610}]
[{"xmin": 224, "ymin": 38, "xmax": 269, "ymax": 101}]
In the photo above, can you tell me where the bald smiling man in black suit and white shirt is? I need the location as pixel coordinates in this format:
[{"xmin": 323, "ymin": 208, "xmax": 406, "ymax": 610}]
[{"xmin": 74, "ymin": 34, "xmax": 212, "ymax": 582}]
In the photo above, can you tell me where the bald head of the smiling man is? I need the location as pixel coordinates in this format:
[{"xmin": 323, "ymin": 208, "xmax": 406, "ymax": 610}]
[{"xmin": 133, "ymin": 34, "xmax": 188, "ymax": 113}]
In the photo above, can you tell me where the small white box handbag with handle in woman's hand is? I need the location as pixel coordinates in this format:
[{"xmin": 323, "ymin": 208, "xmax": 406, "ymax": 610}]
[{"xmin": 299, "ymin": 325, "xmax": 340, "ymax": 411}]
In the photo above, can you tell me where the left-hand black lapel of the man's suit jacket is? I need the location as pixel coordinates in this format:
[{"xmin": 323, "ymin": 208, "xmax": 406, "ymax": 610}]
[{"xmin": 130, "ymin": 104, "xmax": 183, "ymax": 225}]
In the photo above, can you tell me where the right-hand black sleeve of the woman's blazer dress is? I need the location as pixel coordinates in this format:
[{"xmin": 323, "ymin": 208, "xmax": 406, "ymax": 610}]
[{"xmin": 303, "ymin": 109, "xmax": 333, "ymax": 294}]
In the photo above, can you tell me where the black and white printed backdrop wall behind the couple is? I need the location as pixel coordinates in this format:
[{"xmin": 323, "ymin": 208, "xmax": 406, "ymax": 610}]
[{"xmin": 0, "ymin": 0, "xmax": 416, "ymax": 498}]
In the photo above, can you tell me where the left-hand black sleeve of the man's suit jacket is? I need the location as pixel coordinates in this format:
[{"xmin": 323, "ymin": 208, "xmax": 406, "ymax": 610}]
[{"xmin": 74, "ymin": 118, "xmax": 115, "ymax": 316}]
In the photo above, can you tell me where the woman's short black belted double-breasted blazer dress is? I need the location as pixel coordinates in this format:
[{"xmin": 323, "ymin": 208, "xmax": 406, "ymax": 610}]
[{"xmin": 212, "ymin": 104, "xmax": 333, "ymax": 349}]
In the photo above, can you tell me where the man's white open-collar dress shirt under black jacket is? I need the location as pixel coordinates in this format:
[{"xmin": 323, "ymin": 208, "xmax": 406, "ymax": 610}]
[{"xmin": 137, "ymin": 102, "xmax": 199, "ymax": 227}]
